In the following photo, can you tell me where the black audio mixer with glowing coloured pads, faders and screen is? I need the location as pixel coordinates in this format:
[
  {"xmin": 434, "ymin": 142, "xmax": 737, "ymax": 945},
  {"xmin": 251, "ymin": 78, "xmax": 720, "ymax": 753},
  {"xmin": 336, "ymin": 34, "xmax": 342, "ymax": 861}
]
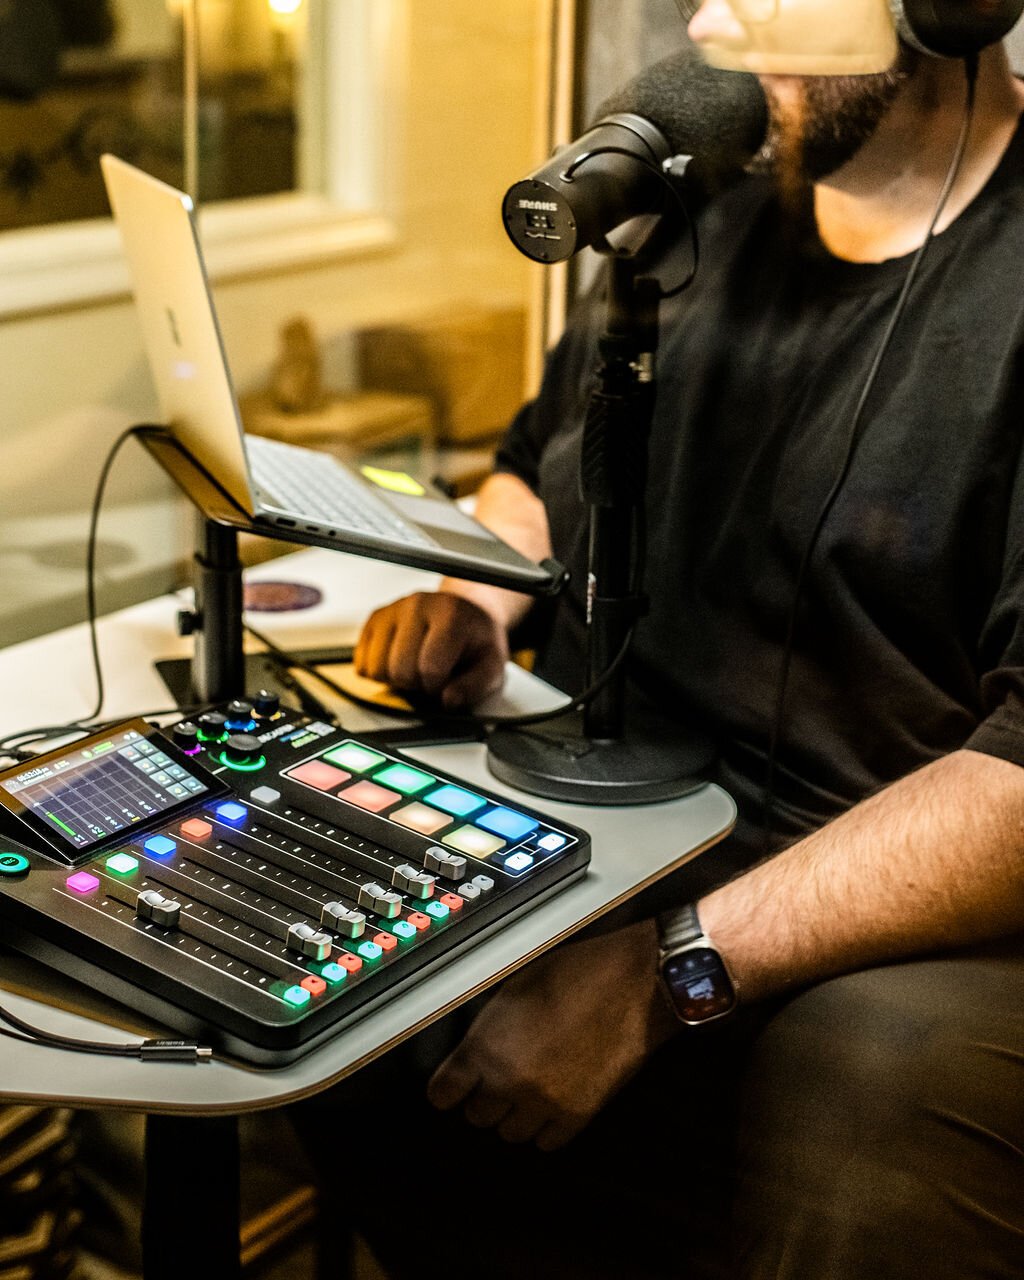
[{"xmin": 0, "ymin": 694, "xmax": 590, "ymax": 1065}]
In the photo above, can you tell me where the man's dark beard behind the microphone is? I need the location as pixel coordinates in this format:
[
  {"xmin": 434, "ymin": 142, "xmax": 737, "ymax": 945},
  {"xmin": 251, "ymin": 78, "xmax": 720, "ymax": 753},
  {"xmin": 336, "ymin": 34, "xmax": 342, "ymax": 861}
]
[{"xmin": 750, "ymin": 45, "xmax": 922, "ymax": 187}]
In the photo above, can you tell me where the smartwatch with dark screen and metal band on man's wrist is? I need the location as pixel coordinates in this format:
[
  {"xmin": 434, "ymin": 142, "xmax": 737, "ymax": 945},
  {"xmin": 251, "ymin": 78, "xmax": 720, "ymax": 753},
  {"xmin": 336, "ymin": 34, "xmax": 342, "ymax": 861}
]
[{"xmin": 658, "ymin": 902, "xmax": 737, "ymax": 1027}]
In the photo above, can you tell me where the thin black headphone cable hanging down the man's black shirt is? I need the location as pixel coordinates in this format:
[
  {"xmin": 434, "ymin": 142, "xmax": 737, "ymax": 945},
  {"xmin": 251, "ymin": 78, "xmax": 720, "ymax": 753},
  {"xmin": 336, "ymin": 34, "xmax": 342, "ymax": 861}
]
[{"xmin": 762, "ymin": 54, "xmax": 978, "ymax": 845}]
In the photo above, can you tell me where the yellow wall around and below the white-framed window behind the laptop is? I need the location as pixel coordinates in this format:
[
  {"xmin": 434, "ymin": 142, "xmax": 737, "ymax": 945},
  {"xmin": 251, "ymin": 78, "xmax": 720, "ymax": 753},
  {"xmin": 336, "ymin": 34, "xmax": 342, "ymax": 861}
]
[{"xmin": 0, "ymin": 0, "xmax": 548, "ymax": 645}]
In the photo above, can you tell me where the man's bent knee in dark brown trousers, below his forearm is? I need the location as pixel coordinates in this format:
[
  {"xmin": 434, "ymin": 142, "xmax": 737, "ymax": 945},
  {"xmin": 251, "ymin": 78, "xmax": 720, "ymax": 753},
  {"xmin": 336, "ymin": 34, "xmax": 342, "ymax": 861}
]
[{"xmin": 737, "ymin": 954, "xmax": 1024, "ymax": 1277}]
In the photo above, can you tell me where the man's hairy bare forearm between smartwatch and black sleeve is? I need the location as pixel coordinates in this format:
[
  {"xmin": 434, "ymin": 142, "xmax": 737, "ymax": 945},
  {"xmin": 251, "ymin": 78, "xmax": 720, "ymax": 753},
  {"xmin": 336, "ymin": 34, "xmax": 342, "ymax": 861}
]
[{"xmin": 699, "ymin": 751, "xmax": 1024, "ymax": 1000}]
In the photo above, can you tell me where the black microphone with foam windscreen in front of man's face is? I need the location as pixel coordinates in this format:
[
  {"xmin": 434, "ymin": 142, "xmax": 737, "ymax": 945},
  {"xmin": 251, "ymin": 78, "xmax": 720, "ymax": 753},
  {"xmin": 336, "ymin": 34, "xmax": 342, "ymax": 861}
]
[{"xmin": 502, "ymin": 45, "xmax": 768, "ymax": 262}]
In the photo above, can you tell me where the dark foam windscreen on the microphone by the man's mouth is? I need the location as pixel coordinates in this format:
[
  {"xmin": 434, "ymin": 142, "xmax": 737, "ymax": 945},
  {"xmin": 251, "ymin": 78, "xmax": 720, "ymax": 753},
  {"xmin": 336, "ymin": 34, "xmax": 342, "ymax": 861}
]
[{"xmin": 595, "ymin": 45, "xmax": 768, "ymax": 173}]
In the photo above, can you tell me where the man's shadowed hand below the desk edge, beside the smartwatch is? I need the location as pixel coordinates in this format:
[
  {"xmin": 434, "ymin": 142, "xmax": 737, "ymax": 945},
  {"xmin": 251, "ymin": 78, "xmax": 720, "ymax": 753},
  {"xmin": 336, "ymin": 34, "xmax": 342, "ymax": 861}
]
[{"xmin": 428, "ymin": 920, "xmax": 678, "ymax": 1151}]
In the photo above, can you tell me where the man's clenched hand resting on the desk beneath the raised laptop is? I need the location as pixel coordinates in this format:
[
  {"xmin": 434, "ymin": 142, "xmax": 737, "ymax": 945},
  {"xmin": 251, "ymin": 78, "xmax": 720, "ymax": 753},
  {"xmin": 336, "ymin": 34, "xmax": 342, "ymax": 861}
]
[{"xmin": 353, "ymin": 591, "xmax": 508, "ymax": 710}]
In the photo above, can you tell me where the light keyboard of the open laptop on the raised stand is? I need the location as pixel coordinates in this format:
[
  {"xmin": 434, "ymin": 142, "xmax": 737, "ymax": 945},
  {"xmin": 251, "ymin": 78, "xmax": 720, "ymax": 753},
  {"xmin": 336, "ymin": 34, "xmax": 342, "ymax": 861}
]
[{"xmin": 252, "ymin": 435, "xmax": 436, "ymax": 547}]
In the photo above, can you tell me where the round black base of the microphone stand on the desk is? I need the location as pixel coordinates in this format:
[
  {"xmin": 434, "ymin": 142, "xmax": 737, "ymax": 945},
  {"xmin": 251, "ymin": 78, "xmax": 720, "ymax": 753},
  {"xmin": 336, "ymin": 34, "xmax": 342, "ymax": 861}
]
[{"xmin": 488, "ymin": 713, "xmax": 716, "ymax": 805}]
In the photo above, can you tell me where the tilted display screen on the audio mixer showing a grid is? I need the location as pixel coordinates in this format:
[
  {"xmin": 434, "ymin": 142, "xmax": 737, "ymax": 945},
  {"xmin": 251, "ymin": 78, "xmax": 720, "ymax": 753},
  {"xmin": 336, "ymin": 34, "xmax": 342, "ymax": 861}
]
[{"xmin": 0, "ymin": 728, "xmax": 210, "ymax": 854}]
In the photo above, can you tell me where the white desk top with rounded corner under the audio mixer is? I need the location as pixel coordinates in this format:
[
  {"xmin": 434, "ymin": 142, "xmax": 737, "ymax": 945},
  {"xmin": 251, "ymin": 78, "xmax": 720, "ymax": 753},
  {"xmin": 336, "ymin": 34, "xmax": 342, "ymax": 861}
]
[{"xmin": 0, "ymin": 550, "xmax": 735, "ymax": 1274}]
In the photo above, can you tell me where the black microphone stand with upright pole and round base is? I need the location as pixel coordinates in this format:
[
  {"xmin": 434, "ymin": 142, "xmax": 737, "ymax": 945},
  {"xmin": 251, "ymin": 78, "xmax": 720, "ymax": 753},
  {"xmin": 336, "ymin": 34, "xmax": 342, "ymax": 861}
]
[{"xmin": 488, "ymin": 255, "xmax": 714, "ymax": 805}]
